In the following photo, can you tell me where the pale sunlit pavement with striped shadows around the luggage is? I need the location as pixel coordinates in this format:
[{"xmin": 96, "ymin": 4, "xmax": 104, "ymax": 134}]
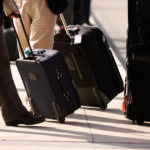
[{"xmin": 0, "ymin": 0, "xmax": 150, "ymax": 150}]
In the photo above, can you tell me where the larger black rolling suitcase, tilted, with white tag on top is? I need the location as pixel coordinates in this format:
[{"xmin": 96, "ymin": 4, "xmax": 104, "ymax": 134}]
[{"xmin": 53, "ymin": 15, "xmax": 124, "ymax": 110}]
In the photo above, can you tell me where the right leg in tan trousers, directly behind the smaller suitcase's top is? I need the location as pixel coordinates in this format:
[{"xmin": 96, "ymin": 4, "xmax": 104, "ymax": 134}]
[{"xmin": 30, "ymin": 0, "xmax": 56, "ymax": 49}]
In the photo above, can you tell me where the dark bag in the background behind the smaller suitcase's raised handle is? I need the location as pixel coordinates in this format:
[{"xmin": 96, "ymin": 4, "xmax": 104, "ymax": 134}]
[{"xmin": 4, "ymin": 28, "xmax": 19, "ymax": 61}]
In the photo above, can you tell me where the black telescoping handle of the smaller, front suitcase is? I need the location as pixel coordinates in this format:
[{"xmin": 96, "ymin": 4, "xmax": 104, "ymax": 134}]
[{"xmin": 9, "ymin": 13, "xmax": 35, "ymax": 60}]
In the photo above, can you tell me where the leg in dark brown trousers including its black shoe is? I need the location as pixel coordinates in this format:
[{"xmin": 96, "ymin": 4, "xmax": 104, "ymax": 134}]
[{"xmin": 0, "ymin": 14, "xmax": 45, "ymax": 126}]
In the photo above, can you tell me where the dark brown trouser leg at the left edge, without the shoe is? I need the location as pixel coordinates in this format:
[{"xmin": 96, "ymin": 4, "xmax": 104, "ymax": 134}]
[{"xmin": 0, "ymin": 26, "xmax": 27, "ymax": 122}]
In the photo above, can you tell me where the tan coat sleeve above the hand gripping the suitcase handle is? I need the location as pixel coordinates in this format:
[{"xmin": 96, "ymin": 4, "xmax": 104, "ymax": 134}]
[{"xmin": 3, "ymin": 0, "xmax": 18, "ymax": 16}]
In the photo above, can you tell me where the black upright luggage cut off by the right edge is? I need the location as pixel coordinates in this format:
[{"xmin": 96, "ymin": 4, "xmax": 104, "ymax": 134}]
[{"xmin": 125, "ymin": 0, "xmax": 150, "ymax": 125}]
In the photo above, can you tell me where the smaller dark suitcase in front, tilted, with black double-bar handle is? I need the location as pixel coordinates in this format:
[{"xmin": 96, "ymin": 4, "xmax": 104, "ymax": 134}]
[{"xmin": 10, "ymin": 17, "xmax": 81, "ymax": 123}]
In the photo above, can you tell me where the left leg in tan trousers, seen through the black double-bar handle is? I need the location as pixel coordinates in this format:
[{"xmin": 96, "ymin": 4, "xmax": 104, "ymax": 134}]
[{"xmin": 14, "ymin": 0, "xmax": 32, "ymax": 56}]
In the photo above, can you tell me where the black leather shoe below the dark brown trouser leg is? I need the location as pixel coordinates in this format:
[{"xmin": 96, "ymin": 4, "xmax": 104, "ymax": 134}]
[{"xmin": 6, "ymin": 112, "xmax": 45, "ymax": 126}]
